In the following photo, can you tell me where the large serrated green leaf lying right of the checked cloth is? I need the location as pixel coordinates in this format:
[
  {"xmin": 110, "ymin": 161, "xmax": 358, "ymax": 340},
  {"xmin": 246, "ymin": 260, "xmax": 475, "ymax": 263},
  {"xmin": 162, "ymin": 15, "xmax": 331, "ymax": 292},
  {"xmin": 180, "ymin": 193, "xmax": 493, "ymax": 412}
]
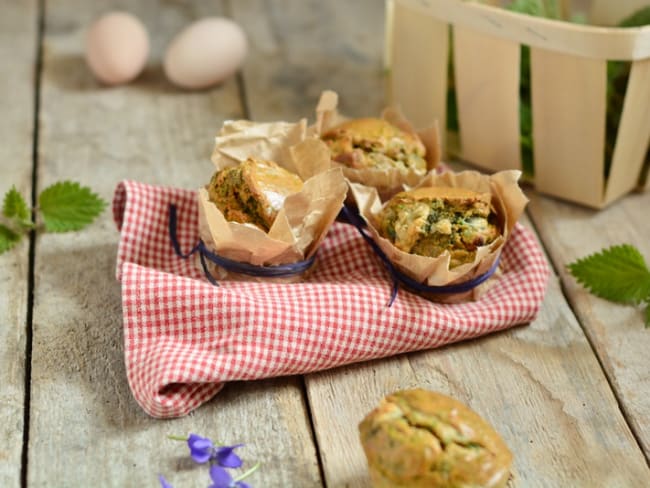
[{"xmin": 568, "ymin": 244, "xmax": 650, "ymax": 304}]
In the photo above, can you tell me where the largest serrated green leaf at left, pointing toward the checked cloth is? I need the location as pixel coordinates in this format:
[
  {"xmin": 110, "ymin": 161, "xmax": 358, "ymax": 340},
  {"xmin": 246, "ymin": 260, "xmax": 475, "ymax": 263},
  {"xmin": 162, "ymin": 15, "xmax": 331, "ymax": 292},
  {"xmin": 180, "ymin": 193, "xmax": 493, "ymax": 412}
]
[{"xmin": 38, "ymin": 181, "xmax": 107, "ymax": 232}]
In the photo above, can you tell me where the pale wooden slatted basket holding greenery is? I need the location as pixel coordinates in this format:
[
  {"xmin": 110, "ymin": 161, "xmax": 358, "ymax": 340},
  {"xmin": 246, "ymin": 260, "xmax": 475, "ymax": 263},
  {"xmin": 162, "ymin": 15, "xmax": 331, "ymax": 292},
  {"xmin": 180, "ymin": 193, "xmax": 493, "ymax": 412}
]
[{"xmin": 386, "ymin": 0, "xmax": 650, "ymax": 208}]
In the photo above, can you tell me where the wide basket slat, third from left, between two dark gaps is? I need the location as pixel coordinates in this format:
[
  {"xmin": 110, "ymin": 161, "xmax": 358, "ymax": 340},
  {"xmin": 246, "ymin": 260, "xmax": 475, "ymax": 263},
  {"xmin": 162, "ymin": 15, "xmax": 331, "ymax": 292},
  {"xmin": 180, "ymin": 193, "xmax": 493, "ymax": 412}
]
[{"xmin": 530, "ymin": 48, "xmax": 607, "ymax": 207}]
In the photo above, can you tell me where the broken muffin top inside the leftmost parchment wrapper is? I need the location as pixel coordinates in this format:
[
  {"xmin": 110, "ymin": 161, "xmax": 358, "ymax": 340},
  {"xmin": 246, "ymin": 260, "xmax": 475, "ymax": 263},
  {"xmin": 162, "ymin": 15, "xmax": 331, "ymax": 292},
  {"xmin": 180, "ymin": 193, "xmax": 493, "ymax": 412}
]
[{"xmin": 208, "ymin": 158, "xmax": 303, "ymax": 231}]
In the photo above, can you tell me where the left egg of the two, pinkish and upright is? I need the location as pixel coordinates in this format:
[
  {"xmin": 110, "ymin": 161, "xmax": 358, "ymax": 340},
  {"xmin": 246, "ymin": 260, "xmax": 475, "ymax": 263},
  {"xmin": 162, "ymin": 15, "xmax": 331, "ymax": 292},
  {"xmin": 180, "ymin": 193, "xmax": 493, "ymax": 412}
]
[{"xmin": 86, "ymin": 12, "xmax": 149, "ymax": 85}]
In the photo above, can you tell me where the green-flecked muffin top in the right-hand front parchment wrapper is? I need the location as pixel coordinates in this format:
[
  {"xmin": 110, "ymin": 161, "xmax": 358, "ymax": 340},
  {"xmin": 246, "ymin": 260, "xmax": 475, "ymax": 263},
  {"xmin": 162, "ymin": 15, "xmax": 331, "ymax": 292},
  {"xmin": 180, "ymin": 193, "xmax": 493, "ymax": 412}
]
[{"xmin": 376, "ymin": 187, "xmax": 500, "ymax": 268}]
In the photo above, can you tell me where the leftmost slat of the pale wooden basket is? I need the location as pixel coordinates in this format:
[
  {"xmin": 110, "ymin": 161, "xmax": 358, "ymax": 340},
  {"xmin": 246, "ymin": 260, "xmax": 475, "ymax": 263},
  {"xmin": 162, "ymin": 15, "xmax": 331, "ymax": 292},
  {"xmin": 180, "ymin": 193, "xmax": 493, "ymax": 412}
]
[{"xmin": 389, "ymin": 3, "xmax": 449, "ymax": 135}]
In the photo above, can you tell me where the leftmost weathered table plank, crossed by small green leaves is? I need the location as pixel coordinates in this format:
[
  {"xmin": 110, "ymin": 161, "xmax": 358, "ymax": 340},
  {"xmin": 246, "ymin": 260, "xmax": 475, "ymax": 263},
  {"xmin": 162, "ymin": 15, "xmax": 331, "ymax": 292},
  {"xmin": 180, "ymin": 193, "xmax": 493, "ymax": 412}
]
[{"xmin": 0, "ymin": 0, "xmax": 38, "ymax": 488}]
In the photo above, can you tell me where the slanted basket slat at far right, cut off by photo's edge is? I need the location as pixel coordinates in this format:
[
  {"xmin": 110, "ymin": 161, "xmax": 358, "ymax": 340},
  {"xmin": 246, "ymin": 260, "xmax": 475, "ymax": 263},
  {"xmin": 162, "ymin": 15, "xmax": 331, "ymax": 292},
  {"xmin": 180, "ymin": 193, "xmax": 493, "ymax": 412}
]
[{"xmin": 605, "ymin": 59, "xmax": 650, "ymax": 203}]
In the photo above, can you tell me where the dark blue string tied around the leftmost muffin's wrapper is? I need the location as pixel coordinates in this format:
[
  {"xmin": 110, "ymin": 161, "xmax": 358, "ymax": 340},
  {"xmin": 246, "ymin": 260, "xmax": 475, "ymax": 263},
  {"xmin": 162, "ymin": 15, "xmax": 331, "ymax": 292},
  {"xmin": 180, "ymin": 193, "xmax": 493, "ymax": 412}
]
[{"xmin": 169, "ymin": 205, "xmax": 316, "ymax": 286}]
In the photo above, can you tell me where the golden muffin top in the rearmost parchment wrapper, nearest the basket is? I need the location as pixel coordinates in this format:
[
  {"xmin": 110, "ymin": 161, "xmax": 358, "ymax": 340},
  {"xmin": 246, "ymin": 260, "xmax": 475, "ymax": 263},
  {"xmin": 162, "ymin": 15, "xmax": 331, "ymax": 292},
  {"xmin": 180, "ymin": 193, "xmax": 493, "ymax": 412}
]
[{"xmin": 321, "ymin": 118, "xmax": 427, "ymax": 174}]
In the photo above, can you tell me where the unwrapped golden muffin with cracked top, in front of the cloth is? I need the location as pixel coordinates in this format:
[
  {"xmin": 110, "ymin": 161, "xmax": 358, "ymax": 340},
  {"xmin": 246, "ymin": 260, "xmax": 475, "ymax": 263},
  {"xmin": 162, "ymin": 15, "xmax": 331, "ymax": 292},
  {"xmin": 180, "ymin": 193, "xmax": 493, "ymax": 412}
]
[{"xmin": 359, "ymin": 389, "xmax": 512, "ymax": 488}]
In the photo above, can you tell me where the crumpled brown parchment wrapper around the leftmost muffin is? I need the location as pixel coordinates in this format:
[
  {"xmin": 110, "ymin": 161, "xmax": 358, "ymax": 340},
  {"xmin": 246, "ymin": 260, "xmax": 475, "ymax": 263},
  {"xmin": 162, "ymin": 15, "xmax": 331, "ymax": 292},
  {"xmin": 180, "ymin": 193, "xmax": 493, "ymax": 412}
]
[{"xmin": 198, "ymin": 120, "xmax": 348, "ymax": 282}]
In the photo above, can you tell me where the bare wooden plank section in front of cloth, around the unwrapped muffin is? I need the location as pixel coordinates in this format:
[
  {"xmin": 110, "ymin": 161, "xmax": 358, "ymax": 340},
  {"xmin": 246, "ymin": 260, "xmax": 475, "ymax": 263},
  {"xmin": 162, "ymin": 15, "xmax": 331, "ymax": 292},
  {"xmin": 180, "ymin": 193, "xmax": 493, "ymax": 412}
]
[{"xmin": 308, "ymin": 215, "xmax": 650, "ymax": 488}]
